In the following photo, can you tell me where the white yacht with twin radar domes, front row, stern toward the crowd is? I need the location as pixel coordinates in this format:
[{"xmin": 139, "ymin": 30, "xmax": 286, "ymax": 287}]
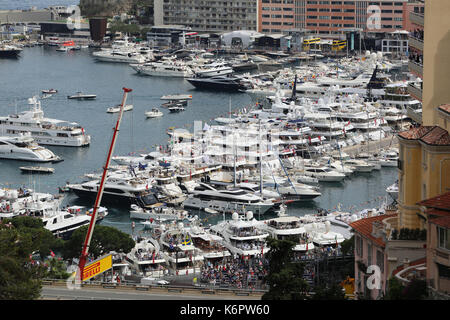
[{"xmin": 211, "ymin": 211, "xmax": 270, "ymax": 257}]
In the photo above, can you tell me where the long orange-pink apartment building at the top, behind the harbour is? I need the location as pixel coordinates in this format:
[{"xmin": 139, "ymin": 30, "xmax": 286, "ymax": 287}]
[{"xmin": 258, "ymin": 0, "xmax": 414, "ymax": 35}]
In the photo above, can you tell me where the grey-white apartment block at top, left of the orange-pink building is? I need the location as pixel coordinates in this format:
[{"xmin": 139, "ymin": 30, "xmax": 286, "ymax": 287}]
[{"xmin": 154, "ymin": 0, "xmax": 258, "ymax": 33}]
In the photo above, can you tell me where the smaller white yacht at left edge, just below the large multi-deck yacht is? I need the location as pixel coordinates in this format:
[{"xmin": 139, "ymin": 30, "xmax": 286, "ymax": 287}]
[{"xmin": 0, "ymin": 133, "xmax": 61, "ymax": 162}]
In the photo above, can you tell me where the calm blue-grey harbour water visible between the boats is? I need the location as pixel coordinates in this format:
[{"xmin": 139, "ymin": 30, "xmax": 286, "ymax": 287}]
[{"xmin": 0, "ymin": 47, "xmax": 397, "ymax": 231}]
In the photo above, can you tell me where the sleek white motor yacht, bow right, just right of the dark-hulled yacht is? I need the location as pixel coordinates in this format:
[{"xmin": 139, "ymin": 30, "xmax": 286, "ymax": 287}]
[{"xmin": 183, "ymin": 182, "xmax": 274, "ymax": 214}]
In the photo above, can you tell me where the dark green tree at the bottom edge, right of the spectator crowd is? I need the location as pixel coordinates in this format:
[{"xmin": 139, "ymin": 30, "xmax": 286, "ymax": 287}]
[{"xmin": 262, "ymin": 238, "xmax": 308, "ymax": 300}]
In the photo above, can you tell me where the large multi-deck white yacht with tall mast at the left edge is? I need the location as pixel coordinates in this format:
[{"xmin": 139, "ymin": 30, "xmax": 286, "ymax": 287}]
[{"xmin": 0, "ymin": 97, "xmax": 91, "ymax": 147}]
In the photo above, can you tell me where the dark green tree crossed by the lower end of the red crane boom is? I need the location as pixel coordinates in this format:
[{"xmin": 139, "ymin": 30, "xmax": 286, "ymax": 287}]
[{"xmin": 62, "ymin": 226, "xmax": 135, "ymax": 259}]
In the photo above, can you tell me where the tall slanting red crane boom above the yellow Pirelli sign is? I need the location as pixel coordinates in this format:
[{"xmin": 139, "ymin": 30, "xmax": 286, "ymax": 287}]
[{"xmin": 77, "ymin": 88, "xmax": 132, "ymax": 281}]
